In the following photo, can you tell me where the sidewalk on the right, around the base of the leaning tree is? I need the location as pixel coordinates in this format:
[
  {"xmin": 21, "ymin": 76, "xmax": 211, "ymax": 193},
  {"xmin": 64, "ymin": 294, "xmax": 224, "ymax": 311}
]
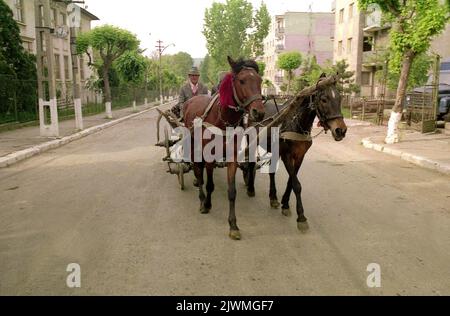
[{"xmin": 362, "ymin": 122, "xmax": 450, "ymax": 175}]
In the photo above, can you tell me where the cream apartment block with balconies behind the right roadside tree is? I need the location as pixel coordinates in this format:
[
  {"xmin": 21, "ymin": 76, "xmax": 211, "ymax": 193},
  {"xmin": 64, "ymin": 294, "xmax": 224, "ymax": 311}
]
[{"xmin": 332, "ymin": 0, "xmax": 450, "ymax": 98}]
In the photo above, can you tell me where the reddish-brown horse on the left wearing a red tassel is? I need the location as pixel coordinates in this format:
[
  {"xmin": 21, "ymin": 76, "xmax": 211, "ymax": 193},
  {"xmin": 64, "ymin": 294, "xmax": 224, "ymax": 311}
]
[{"xmin": 184, "ymin": 57, "xmax": 264, "ymax": 240}]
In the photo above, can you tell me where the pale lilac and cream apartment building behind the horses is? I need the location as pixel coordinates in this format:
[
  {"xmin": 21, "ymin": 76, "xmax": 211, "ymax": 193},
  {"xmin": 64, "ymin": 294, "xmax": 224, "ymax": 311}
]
[{"xmin": 263, "ymin": 12, "xmax": 334, "ymax": 93}]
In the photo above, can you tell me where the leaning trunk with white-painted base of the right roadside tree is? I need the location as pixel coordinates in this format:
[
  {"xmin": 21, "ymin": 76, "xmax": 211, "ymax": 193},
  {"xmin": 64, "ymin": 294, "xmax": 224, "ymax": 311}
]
[{"xmin": 385, "ymin": 50, "xmax": 416, "ymax": 144}]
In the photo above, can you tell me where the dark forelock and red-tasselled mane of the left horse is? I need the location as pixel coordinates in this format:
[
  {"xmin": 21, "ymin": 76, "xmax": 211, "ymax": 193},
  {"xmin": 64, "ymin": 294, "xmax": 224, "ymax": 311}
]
[{"xmin": 219, "ymin": 58, "xmax": 259, "ymax": 108}]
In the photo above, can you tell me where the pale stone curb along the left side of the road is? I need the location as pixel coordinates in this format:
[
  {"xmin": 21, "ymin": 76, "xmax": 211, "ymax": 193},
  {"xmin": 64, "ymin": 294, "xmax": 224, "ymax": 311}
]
[{"xmin": 0, "ymin": 102, "xmax": 171, "ymax": 168}]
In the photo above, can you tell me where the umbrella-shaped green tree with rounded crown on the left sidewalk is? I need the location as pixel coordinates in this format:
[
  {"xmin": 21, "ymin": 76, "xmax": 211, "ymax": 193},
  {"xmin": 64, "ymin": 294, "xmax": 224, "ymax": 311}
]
[{"xmin": 77, "ymin": 25, "xmax": 139, "ymax": 108}]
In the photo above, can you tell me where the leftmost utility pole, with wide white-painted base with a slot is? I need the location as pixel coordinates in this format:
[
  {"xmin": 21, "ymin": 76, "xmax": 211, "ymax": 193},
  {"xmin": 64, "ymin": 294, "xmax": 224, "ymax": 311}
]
[{"xmin": 35, "ymin": 0, "xmax": 59, "ymax": 137}]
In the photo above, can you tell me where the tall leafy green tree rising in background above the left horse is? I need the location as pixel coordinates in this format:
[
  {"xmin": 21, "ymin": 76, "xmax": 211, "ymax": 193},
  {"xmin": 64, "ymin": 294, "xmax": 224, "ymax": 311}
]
[{"xmin": 203, "ymin": 0, "xmax": 270, "ymax": 72}]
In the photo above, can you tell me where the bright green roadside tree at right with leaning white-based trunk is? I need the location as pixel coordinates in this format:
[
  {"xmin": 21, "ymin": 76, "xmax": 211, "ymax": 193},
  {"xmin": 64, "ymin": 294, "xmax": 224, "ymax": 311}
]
[{"xmin": 359, "ymin": 0, "xmax": 450, "ymax": 143}]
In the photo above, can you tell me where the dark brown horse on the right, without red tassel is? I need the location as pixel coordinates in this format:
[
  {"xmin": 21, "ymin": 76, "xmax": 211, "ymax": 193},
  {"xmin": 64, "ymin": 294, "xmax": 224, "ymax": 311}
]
[{"xmin": 244, "ymin": 75, "xmax": 347, "ymax": 231}]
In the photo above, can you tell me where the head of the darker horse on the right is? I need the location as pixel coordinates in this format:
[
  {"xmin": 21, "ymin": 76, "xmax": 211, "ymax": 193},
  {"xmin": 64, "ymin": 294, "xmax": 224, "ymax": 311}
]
[{"xmin": 315, "ymin": 74, "xmax": 347, "ymax": 142}]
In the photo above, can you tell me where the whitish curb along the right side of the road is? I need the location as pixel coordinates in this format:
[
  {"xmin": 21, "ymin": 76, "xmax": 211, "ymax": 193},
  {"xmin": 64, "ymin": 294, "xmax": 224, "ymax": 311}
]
[{"xmin": 361, "ymin": 137, "xmax": 450, "ymax": 175}]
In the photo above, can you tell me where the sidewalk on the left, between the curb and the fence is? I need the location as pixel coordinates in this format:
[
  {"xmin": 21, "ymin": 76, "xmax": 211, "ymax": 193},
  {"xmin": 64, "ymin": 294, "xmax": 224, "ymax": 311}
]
[{"xmin": 0, "ymin": 103, "xmax": 158, "ymax": 158}]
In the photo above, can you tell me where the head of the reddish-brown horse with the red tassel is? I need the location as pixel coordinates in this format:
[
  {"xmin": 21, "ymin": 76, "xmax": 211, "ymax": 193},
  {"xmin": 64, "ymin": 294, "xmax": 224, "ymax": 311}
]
[{"xmin": 224, "ymin": 56, "xmax": 265, "ymax": 122}]
